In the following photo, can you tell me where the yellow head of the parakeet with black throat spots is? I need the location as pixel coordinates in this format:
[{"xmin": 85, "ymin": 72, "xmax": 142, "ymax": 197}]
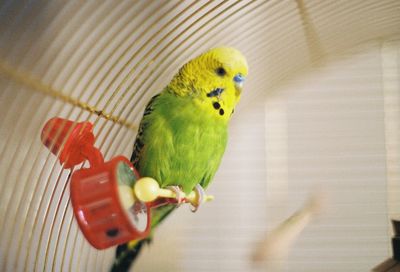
[{"xmin": 170, "ymin": 47, "xmax": 248, "ymax": 120}]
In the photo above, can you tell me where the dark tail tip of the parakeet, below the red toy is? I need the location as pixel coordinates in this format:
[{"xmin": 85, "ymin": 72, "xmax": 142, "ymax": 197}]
[{"xmin": 110, "ymin": 239, "xmax": 148, "ymax": 272}]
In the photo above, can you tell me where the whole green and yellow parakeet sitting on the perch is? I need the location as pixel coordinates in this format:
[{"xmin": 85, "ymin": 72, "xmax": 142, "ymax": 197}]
[{"xmin": 111, "ymin": 47, "xmax": 248, "ymax": 271}]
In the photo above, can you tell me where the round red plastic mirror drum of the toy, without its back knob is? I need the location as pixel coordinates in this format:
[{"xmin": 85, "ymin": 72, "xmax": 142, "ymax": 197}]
[{"xmin": 71, "ymin": 156, "xmax": 150, "ymax": 249}]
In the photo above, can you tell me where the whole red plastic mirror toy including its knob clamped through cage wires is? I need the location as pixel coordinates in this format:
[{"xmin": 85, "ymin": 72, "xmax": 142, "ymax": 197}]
[{"xmin": 41, "ymin": 118, "xmax": 150, "ymax": 249}]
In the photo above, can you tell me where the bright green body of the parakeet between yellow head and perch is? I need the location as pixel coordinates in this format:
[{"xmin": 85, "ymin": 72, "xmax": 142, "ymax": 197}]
[{"xmin": 131, "ymin": 91, "xmax": 227, "ymax": 193}]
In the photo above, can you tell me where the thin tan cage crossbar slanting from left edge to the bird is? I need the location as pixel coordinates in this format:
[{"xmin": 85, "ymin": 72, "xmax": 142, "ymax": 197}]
[{"xmin": 0, "ymin": 60, "xmax": 137, "ymax": 131}]
